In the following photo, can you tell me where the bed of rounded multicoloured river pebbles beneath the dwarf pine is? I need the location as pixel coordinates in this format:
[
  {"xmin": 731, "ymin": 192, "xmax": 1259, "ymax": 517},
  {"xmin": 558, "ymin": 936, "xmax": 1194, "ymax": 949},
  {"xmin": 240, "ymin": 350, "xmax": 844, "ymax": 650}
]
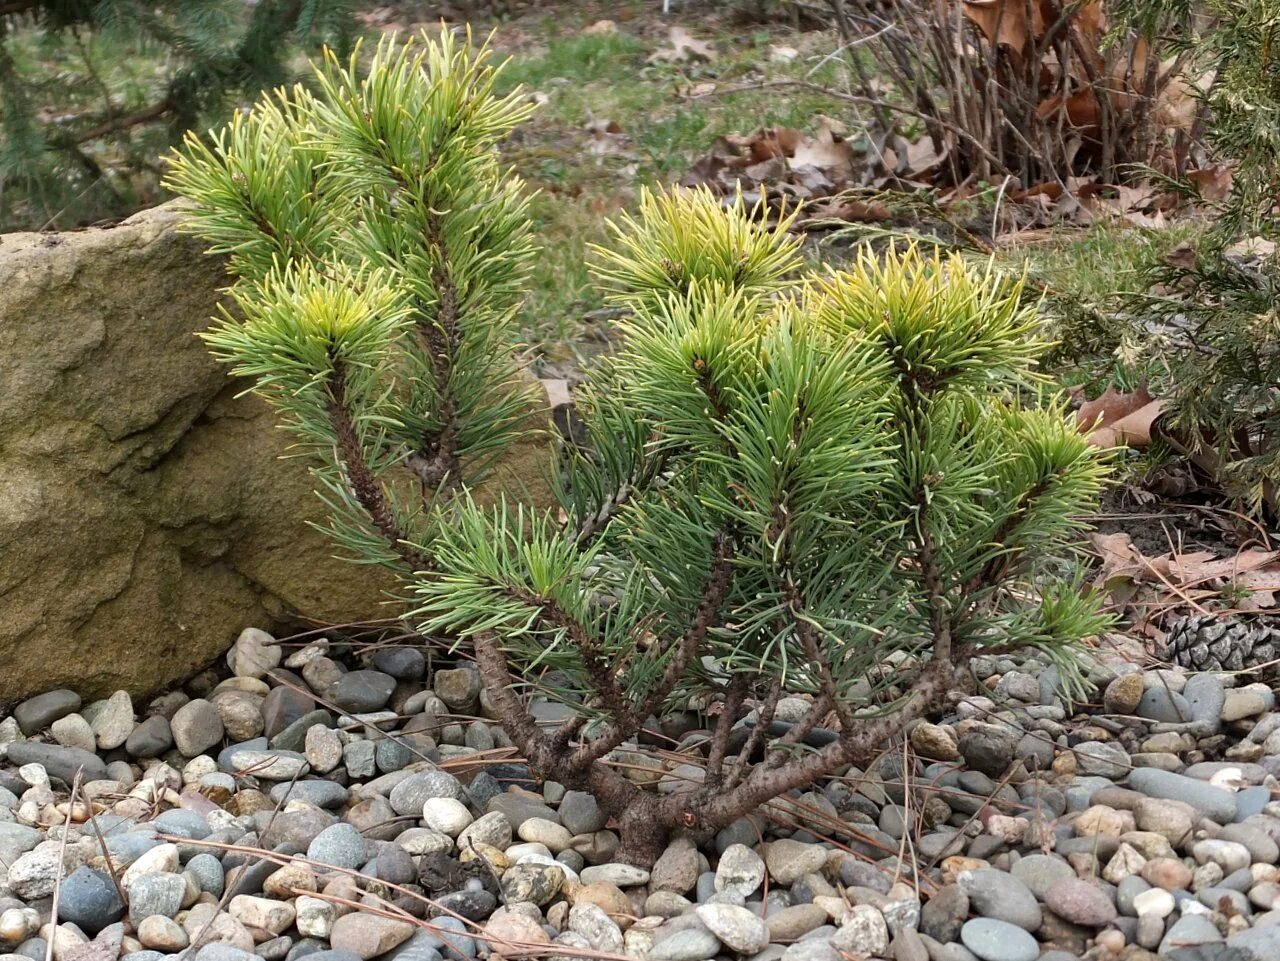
[{"xmin": 0, "ymin": 630, "xmax": 1280, "ymax": 961}]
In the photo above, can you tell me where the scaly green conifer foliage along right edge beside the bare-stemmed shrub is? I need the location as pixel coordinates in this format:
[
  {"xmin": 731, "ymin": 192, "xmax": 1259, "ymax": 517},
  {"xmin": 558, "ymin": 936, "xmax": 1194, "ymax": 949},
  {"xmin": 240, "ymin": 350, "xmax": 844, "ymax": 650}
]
[{"xmin": 1076, "ymin": 0, "xmax": 1280, "ymax": 516}]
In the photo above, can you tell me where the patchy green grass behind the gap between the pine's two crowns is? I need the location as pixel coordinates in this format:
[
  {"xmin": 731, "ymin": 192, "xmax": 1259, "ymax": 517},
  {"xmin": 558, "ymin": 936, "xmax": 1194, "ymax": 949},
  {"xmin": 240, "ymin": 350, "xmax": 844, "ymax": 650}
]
[{"xmin": 488, "ymin": 18, "xmax": 860, "ymax": 353}]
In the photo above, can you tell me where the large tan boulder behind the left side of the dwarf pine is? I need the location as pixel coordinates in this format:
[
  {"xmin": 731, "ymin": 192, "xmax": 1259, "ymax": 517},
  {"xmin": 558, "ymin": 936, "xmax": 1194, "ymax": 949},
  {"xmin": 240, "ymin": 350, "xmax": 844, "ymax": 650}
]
[{"xmin": 0, "ymin": 205, "xmax": 544, "ymax": 703}]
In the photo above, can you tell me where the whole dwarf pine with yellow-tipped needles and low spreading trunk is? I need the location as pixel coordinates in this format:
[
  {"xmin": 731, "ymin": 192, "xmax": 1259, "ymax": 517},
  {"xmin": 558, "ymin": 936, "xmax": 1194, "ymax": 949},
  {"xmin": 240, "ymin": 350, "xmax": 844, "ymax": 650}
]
[{"xmin": 170, "ymin": 28, "xmax": 1103, "ymax": 862}]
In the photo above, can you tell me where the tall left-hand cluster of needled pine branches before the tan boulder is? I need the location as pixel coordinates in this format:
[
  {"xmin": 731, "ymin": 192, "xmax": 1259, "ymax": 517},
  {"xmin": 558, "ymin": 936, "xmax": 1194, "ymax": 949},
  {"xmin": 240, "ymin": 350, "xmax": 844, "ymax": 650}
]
[{"xmin": 166, "ymin": 33, "xmax": 532, "ymax": 573}]
